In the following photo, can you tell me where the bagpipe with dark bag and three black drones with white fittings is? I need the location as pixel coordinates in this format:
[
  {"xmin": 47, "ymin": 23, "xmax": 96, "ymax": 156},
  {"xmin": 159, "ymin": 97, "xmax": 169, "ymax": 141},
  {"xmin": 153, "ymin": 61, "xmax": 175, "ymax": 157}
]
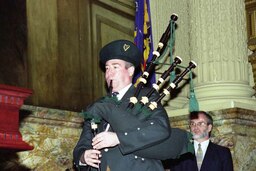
[{"xmin": 82, "ymin": 14, "xmax": 197, "ymax": 160}]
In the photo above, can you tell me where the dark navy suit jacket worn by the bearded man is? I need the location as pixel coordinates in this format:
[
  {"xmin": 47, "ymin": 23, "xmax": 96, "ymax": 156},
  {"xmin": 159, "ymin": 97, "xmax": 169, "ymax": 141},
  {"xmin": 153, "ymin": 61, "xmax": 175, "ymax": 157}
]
[{"xmin": 169, "ymin": 142, "xmax": 233, "ymax": 171}]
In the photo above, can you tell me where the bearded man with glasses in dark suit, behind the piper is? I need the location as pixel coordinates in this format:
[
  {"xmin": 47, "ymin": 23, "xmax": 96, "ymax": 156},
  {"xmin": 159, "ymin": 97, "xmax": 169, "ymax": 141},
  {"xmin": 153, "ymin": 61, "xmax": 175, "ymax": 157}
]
[{"xmin": 169, "ymin": 111, "xmax": 233, "ymax": 171}]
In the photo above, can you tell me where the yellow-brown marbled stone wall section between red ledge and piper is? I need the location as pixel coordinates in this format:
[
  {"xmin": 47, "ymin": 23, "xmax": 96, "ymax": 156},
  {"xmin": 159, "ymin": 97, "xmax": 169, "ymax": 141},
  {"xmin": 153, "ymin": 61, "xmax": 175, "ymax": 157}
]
[{"xmin": 0, "ymin": 105, "xmax": 83, "ymax": 171}]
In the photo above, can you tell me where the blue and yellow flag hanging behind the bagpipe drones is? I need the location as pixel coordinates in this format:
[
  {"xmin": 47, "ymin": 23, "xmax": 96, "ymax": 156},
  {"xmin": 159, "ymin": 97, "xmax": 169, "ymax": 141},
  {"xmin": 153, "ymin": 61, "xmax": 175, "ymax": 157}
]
[{"xmin": 133, "ymin": 0, "xmax": 156, "ymax": 85}]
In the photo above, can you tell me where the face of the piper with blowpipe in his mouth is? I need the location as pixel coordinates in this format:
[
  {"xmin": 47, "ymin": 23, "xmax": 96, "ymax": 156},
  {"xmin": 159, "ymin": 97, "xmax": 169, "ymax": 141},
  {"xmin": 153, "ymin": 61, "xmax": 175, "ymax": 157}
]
[{"xmin": 105, "ymin": 59, "xmax": 134, "ymax": 92}]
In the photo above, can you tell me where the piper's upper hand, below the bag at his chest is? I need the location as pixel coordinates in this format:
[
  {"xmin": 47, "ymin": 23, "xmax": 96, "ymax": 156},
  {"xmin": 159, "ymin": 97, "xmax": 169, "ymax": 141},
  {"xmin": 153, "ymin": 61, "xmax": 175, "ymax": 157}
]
[{"xmin": 92, "ymin": 132, "xmax": 120, "ymax": 150}]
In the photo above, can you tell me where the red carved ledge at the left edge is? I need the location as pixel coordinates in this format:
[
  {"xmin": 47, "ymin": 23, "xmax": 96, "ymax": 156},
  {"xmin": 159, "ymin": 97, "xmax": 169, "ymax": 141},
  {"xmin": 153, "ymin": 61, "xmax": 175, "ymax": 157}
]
[{"xmin": 0, "ymin": 84, "xmax": 34, "ymax": 151}]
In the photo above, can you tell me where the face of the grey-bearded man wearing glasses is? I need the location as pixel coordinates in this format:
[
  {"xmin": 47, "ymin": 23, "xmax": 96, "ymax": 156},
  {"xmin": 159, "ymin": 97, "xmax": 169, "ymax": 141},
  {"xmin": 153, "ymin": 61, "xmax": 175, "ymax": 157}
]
[{"xmin": 190, "ymin": 114, "xmax": 212, "ymax": 142}]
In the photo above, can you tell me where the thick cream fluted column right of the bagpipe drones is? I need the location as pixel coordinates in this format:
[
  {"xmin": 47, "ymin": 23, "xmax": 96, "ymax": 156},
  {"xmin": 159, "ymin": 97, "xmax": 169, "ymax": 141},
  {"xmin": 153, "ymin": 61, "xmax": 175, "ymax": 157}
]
[{"xmin": 189, "ymin": 0, "xmax": 256, "ymax": 110}]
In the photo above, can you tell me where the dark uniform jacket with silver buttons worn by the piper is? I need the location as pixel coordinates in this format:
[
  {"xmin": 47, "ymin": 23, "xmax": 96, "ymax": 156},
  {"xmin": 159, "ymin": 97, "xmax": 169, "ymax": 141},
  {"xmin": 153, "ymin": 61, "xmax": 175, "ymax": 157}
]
[{"xmin": 73, "ymin": 86, "xmax": 170, "ymax": 171}]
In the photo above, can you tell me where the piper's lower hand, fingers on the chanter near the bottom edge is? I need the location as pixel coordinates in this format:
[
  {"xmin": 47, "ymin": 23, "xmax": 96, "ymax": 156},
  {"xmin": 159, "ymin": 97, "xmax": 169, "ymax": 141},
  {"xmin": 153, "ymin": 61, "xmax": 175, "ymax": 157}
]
[{"xmin": 81, "ymin": 149, "xmax": 101, "ymax": 168}]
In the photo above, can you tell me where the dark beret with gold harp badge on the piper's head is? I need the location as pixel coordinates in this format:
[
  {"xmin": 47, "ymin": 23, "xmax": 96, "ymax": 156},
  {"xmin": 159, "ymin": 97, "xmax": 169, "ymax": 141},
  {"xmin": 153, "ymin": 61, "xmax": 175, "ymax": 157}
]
[{"xmin": 100, "ymin": 40, "xmax": 142, "ymax": 67}]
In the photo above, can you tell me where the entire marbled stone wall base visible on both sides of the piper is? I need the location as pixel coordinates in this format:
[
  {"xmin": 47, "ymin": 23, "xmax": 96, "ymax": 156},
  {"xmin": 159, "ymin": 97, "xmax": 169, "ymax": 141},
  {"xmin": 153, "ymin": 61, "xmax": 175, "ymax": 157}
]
[{"xmin": 0, "ymin": 106, "xmax": 256, "ymax": 171}]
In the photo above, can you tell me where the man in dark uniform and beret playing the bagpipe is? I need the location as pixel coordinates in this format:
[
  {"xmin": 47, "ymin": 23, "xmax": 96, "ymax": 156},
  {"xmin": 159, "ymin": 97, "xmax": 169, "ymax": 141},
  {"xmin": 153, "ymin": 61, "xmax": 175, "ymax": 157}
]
[{"xmin": 73, "ymin": 40, "xmax": 170, "ymax": 171}]
